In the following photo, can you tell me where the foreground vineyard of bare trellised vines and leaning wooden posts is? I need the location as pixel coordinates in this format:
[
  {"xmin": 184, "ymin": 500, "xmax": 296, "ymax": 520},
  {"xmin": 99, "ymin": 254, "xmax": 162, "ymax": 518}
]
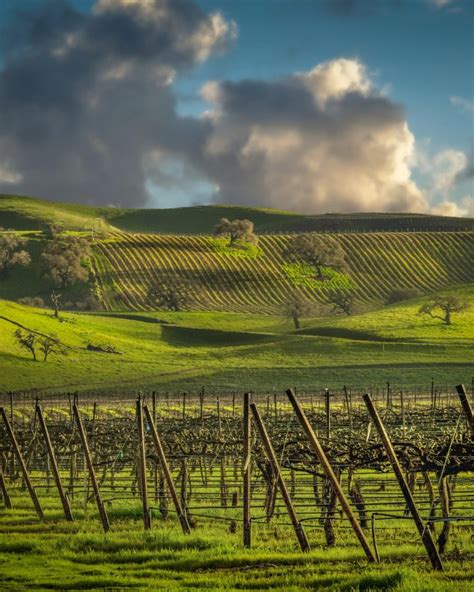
[{"xmin": 0, "ymin": 385, "xmax": 474, "ymax": 589}]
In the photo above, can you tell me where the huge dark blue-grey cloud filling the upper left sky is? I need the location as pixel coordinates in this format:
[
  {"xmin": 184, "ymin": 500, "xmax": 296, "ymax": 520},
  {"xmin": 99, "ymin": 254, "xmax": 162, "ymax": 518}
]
[{"xmin": 0, "ymin": 0, "xmax": 236, "ymax": 206}]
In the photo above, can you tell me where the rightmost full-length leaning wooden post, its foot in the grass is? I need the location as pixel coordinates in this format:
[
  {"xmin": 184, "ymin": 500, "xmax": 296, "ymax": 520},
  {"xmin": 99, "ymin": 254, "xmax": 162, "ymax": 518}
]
[{"xmin": 364, "ymin": 394, "xmax": 443, "ymax": 571}]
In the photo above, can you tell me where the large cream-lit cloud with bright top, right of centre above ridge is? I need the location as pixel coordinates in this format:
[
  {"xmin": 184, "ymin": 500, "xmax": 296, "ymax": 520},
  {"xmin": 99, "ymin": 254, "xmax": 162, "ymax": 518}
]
[{"xmin": 201, "ymin": 59, "xmax": 428, "ymax": 213}]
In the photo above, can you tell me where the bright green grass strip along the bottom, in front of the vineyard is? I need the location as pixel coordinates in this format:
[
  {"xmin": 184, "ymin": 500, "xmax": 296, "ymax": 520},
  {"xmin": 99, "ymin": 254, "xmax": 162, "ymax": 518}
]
[{"xmin": 0, "ymin": 492, "xmax": 474, "ymax": 592}]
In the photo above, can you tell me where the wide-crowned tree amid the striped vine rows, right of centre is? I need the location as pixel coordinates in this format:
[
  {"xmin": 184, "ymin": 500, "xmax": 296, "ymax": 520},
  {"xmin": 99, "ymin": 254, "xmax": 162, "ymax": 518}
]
[{"xmin": 283, "ymin": 232, "xmax": 347, "ymax": 280}]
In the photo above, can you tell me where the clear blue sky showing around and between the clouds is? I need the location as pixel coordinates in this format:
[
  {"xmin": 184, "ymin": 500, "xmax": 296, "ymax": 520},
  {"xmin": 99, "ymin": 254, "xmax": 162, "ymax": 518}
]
[{"xmin": 0, "ymin": 0, "xmax": 474, "ymax": 209}]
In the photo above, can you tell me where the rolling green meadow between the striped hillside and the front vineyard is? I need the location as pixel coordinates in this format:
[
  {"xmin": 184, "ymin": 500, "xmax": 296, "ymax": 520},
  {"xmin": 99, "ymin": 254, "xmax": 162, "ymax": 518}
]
[{"xmin": 0, "ymin": 285, "xmax": 474, "ymax": 391}]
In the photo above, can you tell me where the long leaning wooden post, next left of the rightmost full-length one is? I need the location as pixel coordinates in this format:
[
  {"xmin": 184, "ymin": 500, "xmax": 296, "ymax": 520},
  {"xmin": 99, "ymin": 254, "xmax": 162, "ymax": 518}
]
[{"xmin": 286, "ymin": 389, "xmax": 376, "ymax": 561}]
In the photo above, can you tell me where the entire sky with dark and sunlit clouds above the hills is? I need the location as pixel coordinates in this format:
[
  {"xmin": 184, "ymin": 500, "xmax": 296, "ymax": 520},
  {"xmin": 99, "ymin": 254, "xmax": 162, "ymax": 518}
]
[{"xmin": 0, "ymin": 0, "xmax": 474, "ymax": 216}]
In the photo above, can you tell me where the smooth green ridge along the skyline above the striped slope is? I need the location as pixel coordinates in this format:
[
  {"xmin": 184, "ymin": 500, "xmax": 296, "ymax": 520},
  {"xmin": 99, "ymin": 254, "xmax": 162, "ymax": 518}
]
[{"xmin": 0, "ymin": 194, "xmax": 474, "ymax": 234}]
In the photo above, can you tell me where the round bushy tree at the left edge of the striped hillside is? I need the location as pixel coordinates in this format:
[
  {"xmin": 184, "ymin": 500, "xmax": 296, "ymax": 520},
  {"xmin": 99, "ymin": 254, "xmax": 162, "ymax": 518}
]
[{"xmin": 41, "ymin": 235, "xmax": 91, "ymax": 289}]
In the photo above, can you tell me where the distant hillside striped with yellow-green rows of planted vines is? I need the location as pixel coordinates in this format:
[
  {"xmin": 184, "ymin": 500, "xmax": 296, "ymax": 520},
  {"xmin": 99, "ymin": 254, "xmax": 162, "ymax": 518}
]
[{"xmin": 95, "ymin": 232, "xmax": 474, "ymax": 313}]
